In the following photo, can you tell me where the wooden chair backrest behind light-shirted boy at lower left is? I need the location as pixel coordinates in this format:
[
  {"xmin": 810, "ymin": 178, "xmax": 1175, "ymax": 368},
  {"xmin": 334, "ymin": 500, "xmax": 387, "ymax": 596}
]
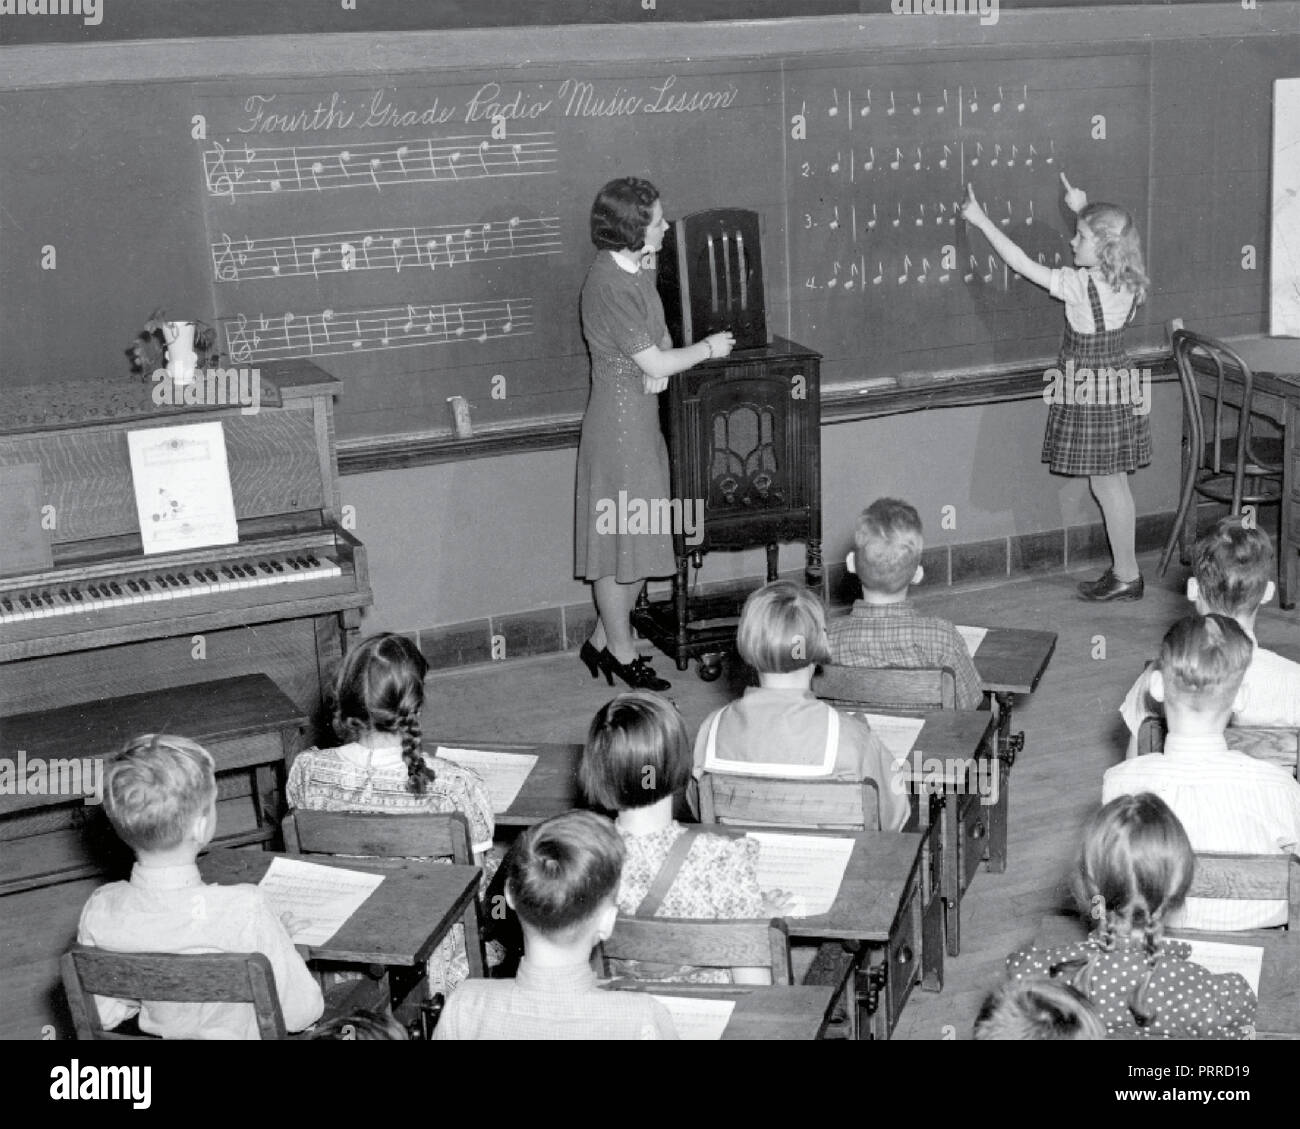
[{"xmin": 62, "ymin": 944, "xmax": 286, "ymax": 1039}]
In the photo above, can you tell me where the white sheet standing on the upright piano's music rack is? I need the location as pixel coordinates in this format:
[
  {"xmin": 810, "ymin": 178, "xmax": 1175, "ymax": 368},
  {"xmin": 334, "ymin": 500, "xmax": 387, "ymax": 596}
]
[{"xmin": 126, "ymin": 420, "xmax": 239, "ymax": 557}]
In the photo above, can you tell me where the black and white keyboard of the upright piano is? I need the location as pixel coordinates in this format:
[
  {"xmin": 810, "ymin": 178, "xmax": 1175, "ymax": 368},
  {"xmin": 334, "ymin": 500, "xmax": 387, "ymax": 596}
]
[{"xmin": 0, "ymin": 553, "xmax": 342, "ymax": 624}]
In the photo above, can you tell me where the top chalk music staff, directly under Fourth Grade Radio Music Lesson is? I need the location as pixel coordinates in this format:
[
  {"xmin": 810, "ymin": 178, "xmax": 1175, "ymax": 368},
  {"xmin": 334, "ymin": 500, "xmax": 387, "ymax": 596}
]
[{"xmin": 203, "ymin": 130, "xmax": 559, "ymax": 202}]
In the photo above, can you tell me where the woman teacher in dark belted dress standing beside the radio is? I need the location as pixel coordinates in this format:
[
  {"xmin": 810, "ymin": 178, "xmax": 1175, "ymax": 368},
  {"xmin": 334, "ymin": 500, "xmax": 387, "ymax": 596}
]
[{"xmin": 575, "ymin": 177, "xmax": 736, "ymax": 691}]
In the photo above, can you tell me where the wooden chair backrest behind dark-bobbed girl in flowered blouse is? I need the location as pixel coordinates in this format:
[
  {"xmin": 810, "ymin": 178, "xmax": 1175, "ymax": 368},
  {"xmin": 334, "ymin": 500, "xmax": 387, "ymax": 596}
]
[{"xmin": 601, "ymin": 913, "xmax": 794, "ymax": 985}]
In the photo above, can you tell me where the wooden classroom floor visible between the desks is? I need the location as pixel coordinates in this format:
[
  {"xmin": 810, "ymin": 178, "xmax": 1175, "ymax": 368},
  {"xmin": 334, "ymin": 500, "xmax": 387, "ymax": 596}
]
[{"xmin": 0, "ymin": 559, "xmax": 1300, "ymax": 1039}]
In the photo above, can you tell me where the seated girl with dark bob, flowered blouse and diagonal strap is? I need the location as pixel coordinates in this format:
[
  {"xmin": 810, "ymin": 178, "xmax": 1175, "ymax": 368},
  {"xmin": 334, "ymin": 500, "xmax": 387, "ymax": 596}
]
[{"xmin": 579, "ymin": 691, "xmax": 790, "ymax": 983}]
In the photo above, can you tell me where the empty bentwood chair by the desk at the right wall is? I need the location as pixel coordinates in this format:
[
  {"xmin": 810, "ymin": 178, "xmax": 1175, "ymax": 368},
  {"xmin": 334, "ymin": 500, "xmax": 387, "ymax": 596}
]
[{"xmin": 1160, "ymin": 329, "xmax": 1286, "ymax": 576}]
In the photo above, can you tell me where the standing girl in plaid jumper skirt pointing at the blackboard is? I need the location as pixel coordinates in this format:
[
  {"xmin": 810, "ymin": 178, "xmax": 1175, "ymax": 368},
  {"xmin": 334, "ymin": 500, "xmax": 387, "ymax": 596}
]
[{"xmin": 962, "ymin": 173, "xmax": 1151, "ymax": 600}]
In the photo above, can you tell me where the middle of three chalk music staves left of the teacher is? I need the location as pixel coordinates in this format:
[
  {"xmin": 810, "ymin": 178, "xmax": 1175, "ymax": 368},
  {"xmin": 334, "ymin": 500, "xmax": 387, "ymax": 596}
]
[{"xmin": 211, "ymin": 216, "xmax": 563, "ymax": 282}]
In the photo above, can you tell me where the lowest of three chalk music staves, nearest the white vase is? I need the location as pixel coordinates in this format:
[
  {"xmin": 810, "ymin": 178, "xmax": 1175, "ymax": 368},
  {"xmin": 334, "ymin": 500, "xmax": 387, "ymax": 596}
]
[{"xmin": 221, "ymin": 298, "xmax": 533, "ymax": 364}]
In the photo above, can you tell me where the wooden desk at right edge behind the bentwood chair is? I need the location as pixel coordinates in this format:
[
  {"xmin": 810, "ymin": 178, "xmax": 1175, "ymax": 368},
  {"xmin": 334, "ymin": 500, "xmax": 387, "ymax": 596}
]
[{"xmin": 1197, "ymin": 336, "xmax": 1300, "ymax": 610}]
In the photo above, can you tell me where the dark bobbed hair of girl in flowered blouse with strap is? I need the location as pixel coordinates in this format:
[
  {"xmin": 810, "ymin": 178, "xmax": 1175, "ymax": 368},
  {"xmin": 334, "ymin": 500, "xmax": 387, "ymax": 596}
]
[{"xmin": 579, "ymin": 691, "xmax": 692, "ymax": 812}]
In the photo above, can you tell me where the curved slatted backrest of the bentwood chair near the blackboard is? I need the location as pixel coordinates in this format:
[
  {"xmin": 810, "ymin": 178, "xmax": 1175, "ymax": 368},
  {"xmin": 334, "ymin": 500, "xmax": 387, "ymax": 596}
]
[{"xmin": 1170, "ymin": 329, "xmax": 1260, "ymax": 504}]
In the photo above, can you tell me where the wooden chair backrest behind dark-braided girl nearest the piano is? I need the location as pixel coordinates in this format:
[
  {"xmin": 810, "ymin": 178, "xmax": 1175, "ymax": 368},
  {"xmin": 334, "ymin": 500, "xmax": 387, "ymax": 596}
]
[{"xmin": 281, "ymin": 809, "xmax": 473, "ymax": 866}]
